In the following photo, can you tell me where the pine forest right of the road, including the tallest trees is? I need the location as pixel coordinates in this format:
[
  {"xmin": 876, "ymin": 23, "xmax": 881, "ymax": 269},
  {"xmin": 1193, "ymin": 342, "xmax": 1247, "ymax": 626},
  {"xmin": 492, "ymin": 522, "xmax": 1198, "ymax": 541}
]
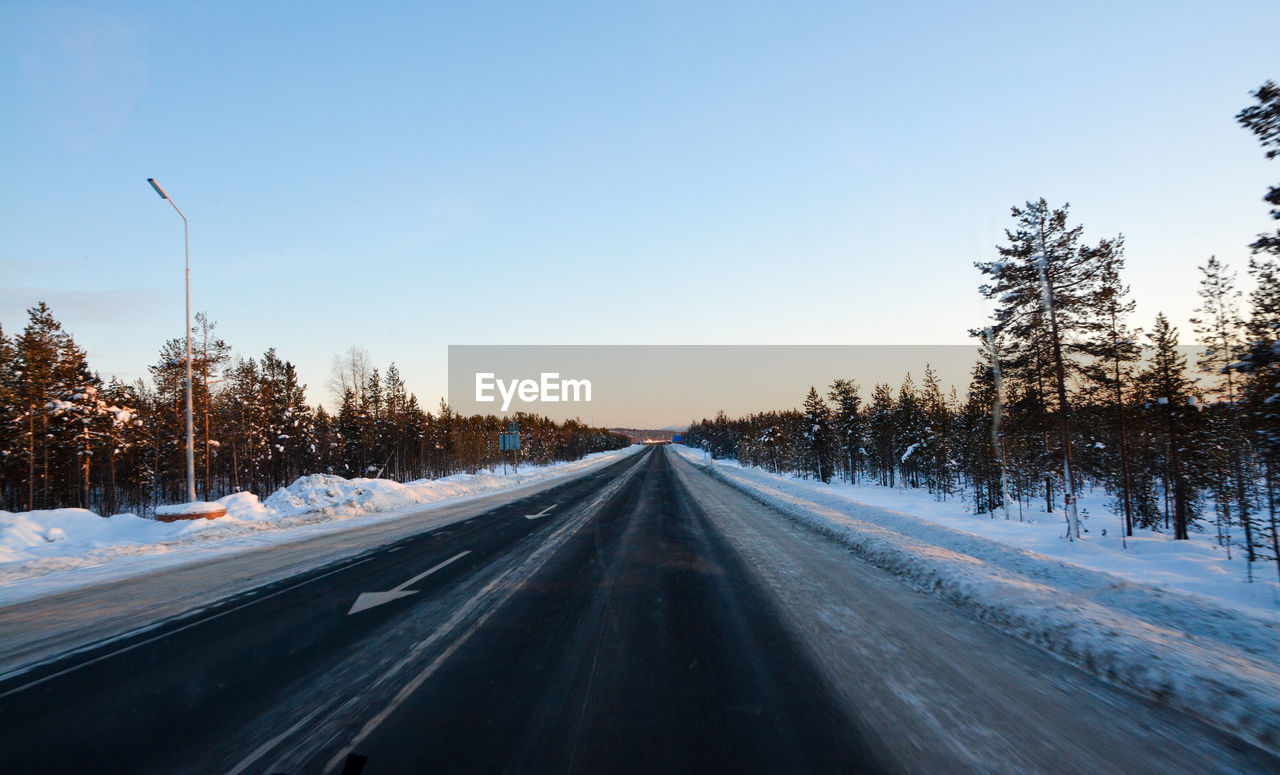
[{"xmin": 685, "ymin": 82, "xmax": 1280, "ymax": 576}]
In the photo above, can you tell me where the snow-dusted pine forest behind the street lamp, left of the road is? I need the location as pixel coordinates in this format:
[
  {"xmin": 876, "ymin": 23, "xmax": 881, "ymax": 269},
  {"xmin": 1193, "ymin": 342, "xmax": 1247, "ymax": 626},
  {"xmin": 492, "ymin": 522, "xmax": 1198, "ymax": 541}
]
[{"xmin": 0, "ymin": 311, "xmax": 630, "ymax": 515}]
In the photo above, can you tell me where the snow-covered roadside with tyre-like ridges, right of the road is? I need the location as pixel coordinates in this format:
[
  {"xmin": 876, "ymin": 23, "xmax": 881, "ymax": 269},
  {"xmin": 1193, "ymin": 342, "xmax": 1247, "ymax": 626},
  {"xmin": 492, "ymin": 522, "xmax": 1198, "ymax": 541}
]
[{"xmin": 672, "ymin": 447, "xmax": 1280, "ymax": 751}]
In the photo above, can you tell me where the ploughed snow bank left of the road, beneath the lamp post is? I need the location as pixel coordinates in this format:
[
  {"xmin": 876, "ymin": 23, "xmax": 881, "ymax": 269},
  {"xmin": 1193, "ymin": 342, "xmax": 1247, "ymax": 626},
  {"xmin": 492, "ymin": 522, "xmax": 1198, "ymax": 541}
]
[{"xmin": 0, "ymin": 446, "xmax": 641, "ymax": 605}]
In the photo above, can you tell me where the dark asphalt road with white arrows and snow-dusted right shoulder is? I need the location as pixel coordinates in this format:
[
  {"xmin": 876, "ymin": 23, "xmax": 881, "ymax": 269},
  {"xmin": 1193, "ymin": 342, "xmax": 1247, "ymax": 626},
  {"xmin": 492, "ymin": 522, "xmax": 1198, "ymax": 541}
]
[{"xmin": 0, "ymin": 448, "xmax": 1280, "ymax": 774}]
